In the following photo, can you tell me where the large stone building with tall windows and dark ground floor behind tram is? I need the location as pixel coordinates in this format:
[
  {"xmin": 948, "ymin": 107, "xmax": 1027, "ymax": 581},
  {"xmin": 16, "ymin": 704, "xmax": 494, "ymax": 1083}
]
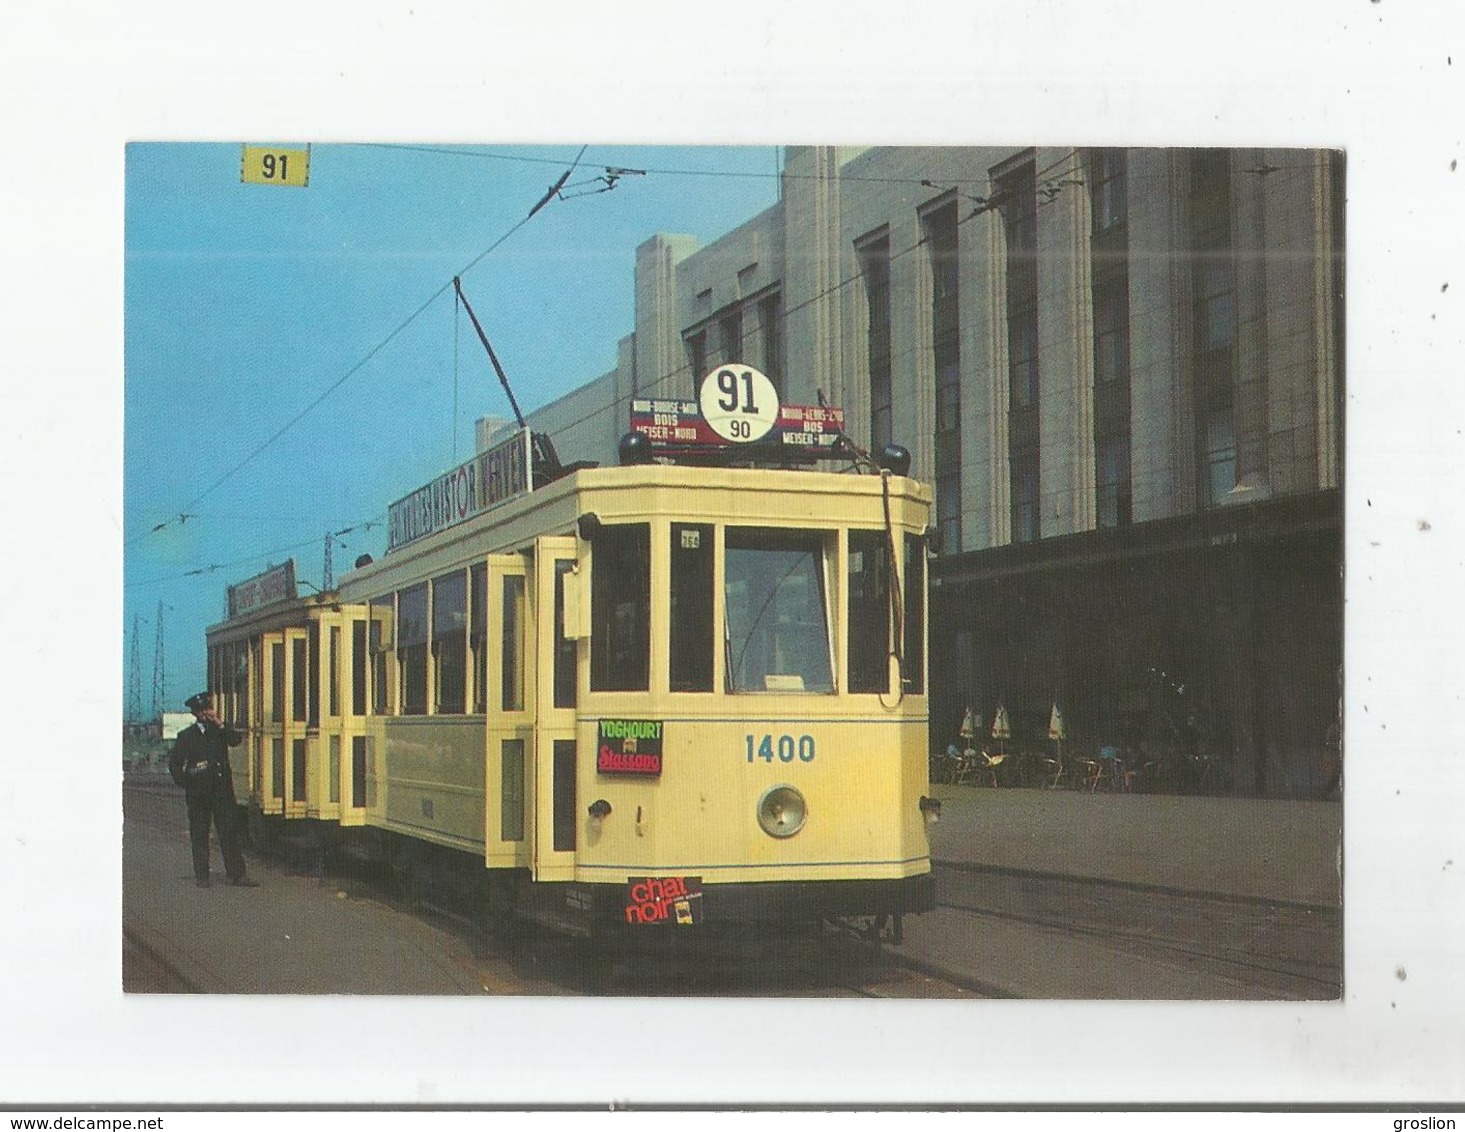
[{"xmin": 532, "ymin": 146, "xmax": 1343, "ymax": 797}]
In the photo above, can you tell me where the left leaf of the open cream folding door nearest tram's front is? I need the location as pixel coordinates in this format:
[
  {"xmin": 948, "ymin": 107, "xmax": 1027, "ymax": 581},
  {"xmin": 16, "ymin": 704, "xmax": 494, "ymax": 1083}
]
[{"xmin": 473, "ymin": 554, "xmax": 536, "ymax": 868}]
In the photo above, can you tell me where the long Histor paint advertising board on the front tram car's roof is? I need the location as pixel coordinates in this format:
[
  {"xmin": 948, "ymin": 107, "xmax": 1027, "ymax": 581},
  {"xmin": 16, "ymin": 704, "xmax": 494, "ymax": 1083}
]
[{"xmin": 387, "ymin": 429, "xmax": 533, "ymax": 554}]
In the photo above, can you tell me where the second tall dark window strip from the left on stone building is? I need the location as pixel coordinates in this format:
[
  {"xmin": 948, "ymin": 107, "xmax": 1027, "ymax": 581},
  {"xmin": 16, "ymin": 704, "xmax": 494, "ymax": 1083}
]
[{"xmin": 924, "ymin": 201, "xmax": 961, "ymax": 554}]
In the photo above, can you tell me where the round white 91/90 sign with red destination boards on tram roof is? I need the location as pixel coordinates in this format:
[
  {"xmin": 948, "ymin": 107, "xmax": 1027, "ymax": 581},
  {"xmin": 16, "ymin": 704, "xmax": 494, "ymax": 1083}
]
[{"xmin": 631, "ymin": 365, "xmax": 844, "ymax": 458}]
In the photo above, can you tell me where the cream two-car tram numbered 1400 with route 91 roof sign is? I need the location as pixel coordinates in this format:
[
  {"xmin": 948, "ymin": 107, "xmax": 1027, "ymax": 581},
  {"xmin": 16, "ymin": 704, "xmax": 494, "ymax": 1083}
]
[{"xmin": 208, "ymin": 366, "xmax": 939, "ymax": 933}]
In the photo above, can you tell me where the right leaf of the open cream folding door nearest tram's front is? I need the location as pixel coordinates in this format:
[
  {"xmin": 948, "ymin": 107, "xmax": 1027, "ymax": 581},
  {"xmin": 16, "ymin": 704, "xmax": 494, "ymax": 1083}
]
[{"xmin": 535, "ymin": 535, "xmax": 580, "ymax": 880}]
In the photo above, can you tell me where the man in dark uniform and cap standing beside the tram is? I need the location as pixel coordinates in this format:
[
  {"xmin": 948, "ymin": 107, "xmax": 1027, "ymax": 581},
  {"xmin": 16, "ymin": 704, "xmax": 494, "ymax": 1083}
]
[{"xmin": 168, "ymin": 691, "xmax": 258, "ymax": 889}]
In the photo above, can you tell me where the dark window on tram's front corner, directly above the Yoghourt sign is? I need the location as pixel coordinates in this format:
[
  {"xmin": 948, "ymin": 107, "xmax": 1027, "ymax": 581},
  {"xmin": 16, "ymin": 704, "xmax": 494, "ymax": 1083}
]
[{"xmin": 590, "ymin": 523, "xmax": 650, "ymax": 691}]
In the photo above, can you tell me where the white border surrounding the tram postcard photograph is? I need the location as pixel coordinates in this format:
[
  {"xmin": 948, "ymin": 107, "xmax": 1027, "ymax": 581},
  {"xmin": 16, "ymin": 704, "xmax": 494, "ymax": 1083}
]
[{"xmin": 0, "ymin": 0, "xmax": 1465, "ymax": 1103}]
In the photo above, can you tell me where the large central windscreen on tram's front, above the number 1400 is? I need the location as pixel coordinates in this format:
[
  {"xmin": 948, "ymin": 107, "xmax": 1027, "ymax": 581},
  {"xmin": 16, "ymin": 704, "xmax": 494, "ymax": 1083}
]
[{"xmin": 725, "ymin": 527, "xmax": 834, "ymax": 693}]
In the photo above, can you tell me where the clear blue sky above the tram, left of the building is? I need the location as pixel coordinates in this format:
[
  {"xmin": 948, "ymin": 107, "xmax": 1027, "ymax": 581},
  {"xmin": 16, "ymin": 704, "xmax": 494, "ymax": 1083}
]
[{"xmin": 120, "ymin": 138, "xmax": 778, "ymax": 705}]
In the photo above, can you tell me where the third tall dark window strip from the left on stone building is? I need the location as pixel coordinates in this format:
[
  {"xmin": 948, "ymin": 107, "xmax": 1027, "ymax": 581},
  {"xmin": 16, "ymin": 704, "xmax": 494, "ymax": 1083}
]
[{"xmin": 996, "ymin": 163, "xmax": 1042, "ymax": 542}]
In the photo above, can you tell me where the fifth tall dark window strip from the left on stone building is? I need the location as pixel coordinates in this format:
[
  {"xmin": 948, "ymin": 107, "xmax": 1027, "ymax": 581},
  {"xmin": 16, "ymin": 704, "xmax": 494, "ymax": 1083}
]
[{"xmin": 1190, "ymin": 149, "xmax": 1236, "ymax": 507}]
